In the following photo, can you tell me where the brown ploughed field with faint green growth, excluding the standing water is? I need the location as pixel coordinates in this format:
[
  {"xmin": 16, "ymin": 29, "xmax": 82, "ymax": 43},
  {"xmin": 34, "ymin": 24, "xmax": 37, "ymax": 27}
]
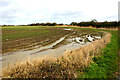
[{"xmin": 2, "ymin": 26, "xmax": 102, "ymax": 54}]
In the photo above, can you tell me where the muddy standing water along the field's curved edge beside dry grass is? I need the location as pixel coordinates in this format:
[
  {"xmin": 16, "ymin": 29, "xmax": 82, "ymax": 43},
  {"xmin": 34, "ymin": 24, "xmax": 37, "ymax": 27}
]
[{"xmin": 0, "ymin": 29, "xmax": 102, "ymax": 68}]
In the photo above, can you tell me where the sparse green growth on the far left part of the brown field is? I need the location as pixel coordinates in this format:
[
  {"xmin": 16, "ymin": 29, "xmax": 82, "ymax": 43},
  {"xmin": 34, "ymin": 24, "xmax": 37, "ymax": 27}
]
[{"xmin": 2, "ymin": 26, "xmax": 49, "ymax": 41}]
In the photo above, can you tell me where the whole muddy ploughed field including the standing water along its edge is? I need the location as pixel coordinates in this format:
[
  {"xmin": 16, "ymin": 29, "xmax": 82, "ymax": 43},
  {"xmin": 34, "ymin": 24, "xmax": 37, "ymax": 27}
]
[{"xmin": 0, "ymin": 26, "xmax": 104, "ymax": 67}]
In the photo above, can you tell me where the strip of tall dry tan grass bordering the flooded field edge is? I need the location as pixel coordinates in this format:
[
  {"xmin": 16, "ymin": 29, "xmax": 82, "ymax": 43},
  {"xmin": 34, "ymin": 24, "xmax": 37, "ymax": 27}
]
[{"xmin": 3, "ymin": 33, "xmax": 111, "ymax": 78}]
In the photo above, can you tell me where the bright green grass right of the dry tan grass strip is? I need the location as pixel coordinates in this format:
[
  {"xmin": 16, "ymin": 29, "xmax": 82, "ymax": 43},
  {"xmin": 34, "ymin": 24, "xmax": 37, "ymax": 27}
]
[{"xmin": 79, "ymin": 31, "xmax": 118, "ymax": 79}]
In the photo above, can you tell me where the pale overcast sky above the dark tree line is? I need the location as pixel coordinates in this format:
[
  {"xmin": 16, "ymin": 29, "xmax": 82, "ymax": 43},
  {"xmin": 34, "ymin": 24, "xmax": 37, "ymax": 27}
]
[{"xmin": 0, "ymin": 0, "xmax": 119, "ymax": 25}]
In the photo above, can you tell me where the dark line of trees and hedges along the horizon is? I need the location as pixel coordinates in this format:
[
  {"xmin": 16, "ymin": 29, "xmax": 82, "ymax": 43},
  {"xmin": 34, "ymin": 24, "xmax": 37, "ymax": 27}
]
[{"xmin": 2, "ymin": 19, "xmax": 120, "ymax": 28}]
